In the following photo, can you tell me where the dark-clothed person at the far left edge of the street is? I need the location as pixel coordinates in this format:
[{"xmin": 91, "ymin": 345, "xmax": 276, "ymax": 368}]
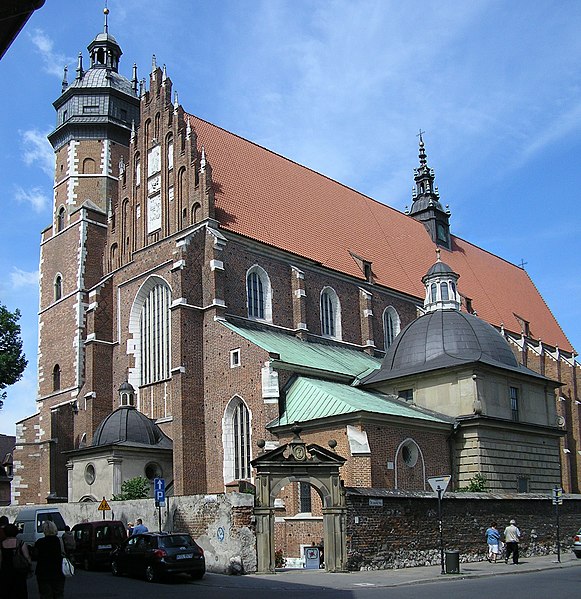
[{"xmin": 0, "ymin": 524, "xmax": 32, "ymax": 599}]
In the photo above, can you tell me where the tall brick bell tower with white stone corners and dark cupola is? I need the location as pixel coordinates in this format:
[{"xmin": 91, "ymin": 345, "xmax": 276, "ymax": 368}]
[{"xmin": 24, "ymin": 8, "xmax": 140, "ymax": 503}]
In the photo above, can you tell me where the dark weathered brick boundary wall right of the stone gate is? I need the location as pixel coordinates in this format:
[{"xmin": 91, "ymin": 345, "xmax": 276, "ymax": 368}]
[{"xmin": 346, "ymin": 488, "xmax": 581, "ymax": 570}]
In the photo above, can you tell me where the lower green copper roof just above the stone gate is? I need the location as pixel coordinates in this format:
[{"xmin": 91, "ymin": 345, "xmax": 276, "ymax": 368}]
[{"xmin": 269, "ymin": 377, "xmax": 448, "ymax": 427}]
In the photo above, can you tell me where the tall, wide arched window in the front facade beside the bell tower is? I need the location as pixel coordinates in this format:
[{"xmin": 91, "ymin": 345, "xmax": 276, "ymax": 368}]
[{"xmin": 139, "ymin": 283, "xmax": 171, "ymax": 385}]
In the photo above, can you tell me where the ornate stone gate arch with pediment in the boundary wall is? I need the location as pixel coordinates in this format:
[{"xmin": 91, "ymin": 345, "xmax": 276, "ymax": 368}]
[{"xmin": 252, "ymin": 426, "xmax": 347, "ymax": 574}]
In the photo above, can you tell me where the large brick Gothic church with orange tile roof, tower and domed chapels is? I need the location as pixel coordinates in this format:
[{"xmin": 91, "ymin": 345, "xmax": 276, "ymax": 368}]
[{"xmin": 12, "ymin": 16, "xmax": 581, "ymax": 516}]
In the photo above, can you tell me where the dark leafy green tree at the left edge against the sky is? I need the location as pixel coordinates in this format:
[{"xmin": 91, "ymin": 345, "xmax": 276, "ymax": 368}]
[{"xmin": 0, "ymin": 304, "xmax": 28, "ymax": 409}]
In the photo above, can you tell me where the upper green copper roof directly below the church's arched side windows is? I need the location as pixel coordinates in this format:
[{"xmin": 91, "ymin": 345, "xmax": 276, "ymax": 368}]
[{"xmin": 222, "ymin": 321, "xmax": 381, "ymax": 378}]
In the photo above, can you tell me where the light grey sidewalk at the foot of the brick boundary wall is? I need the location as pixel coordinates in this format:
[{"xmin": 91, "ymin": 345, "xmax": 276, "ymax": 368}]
[{"xmin": 250, "ymin": 551, "xmax": 581, "ymax": 589}]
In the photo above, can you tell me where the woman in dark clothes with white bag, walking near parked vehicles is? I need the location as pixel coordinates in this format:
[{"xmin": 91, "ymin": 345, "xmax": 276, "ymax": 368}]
[{"xmin": 34, "ymin": 520, "xmax": 65, "ymax": 599}]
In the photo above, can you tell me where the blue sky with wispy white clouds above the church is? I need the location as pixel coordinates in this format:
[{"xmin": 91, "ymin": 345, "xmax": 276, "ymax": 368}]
[{"xmin": 0, "ymin": 0, "xmax": 581, "ymax": 434}]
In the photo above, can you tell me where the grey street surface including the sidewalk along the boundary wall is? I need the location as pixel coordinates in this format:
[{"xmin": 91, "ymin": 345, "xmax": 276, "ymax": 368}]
[{"xmin": 23, "ymin": 553, "xmax": 581, "ymax": 599}]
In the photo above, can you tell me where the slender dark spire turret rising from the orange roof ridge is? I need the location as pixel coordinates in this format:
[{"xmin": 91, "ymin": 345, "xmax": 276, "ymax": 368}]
[{"xmin": 409, "ymin": 131, "xmax": 451, "ymax": 250}]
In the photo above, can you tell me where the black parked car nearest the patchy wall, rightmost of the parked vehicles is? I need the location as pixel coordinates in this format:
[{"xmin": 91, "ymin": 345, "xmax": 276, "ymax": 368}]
[{"xmin": 111, "ymin": 532, "xmax": 206, "ymax": 582}]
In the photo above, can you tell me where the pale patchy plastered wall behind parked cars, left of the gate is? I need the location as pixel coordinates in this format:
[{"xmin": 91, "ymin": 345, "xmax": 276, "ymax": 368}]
[{"xmin": 2, "ymin": 493, "xmax": 256, "ymax": 573}]
